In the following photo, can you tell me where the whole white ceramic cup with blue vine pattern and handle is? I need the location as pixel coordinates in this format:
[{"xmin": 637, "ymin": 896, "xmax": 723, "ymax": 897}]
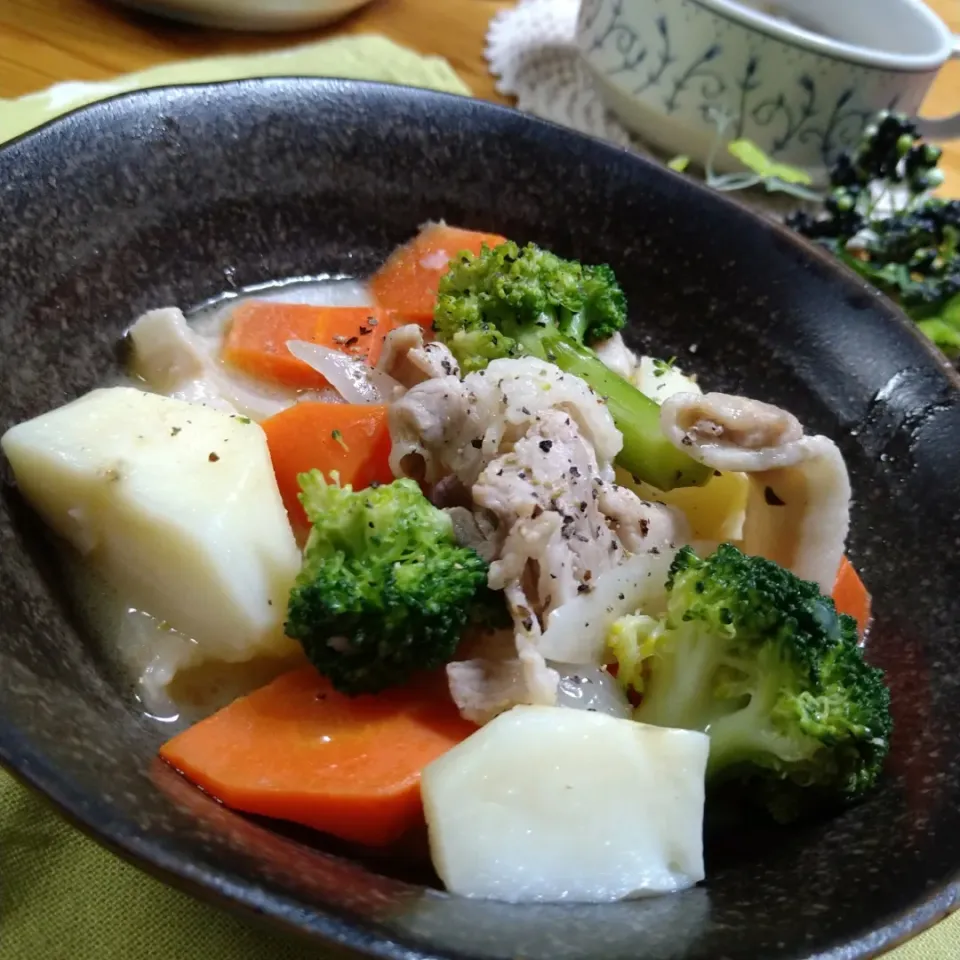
[{"xmin": 577, "ymin": 0, "xmax": 960, "ymax": 183}]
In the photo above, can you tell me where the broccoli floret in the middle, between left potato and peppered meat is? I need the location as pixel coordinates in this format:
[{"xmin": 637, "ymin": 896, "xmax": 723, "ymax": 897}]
[{"xmin": 286, "ymin": 470, "xmax": 488, "ymax": 695}]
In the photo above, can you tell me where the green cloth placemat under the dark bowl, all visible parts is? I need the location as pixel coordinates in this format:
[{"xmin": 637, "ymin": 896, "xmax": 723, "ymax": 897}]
[{"xmin": 0, "ymin": 33, "xmax": 960, "ymax": 960}]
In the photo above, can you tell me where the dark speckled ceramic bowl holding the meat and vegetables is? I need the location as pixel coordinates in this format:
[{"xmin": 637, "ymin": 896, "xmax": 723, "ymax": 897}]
[{"xmin": 0, "ymin": 80, "xmax": 960, "ymax": 960}]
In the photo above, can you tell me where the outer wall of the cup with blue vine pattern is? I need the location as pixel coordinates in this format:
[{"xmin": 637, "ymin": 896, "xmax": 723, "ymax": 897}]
[{"xmin": 579, "ymin": 0, "xmax": 917, "ymax": 166}]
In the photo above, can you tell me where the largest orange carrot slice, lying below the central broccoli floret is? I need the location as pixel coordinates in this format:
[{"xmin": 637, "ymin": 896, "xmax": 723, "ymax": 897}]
[{"xmin": 160, "ymin": 667, "xmax": 476, "ymax": 846}]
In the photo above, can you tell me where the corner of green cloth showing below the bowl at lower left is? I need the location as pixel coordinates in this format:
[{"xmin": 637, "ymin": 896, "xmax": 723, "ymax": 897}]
[{"xmin": 0, "ymin": 771, "xmax": 345, "ymax": 960}]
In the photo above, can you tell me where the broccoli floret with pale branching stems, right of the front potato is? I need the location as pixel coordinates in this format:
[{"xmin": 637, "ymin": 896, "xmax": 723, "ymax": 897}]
[{"xmin": 608, "ymin": 544, "xmax": 892, "ymax": 821}]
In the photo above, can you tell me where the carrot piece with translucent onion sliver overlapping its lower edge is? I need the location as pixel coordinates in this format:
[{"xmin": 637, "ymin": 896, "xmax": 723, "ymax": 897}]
[{"xmin": 223, "ymin": 300, "xmax": 389, "ymax": 390}]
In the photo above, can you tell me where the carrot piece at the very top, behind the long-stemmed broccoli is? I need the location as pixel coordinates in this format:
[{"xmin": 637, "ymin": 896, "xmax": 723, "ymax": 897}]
[{"xmin": 371, "ymin": 223, "xmax": 506, "ymax": 327}]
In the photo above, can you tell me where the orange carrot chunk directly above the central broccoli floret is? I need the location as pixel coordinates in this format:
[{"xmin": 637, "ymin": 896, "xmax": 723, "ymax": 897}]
[{"xmin": 260, "ymin": 401, "xmax": 393, "ymax": 530}]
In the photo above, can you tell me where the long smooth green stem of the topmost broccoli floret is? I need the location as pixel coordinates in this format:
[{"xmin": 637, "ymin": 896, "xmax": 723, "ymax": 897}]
[{"xmin": 531, "ymin": 332, "xmax": 713, "ymax": 490}]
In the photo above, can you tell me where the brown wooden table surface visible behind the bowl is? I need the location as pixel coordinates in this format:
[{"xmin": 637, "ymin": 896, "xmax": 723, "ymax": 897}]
[{"xmin": 0, "ymin": 0, "xmax": 960, "ymax": 196}]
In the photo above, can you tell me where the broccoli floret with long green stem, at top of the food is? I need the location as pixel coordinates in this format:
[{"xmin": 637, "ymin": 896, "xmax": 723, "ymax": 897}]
[{"xmin": 434, "ymin": 242, "xmax": 712, "ymax": 490}]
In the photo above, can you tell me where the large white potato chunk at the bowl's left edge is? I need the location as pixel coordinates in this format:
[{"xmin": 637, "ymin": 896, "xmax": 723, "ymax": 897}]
[{"xmin": 0, "ymin": 387, "xmax": 300, "ymax": 663}]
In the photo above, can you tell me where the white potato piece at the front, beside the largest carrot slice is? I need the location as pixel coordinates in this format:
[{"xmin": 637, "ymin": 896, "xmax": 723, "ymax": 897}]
[{"xmin": 421, "ymin": 706, "xmax": 709, "ymax": 903}]
